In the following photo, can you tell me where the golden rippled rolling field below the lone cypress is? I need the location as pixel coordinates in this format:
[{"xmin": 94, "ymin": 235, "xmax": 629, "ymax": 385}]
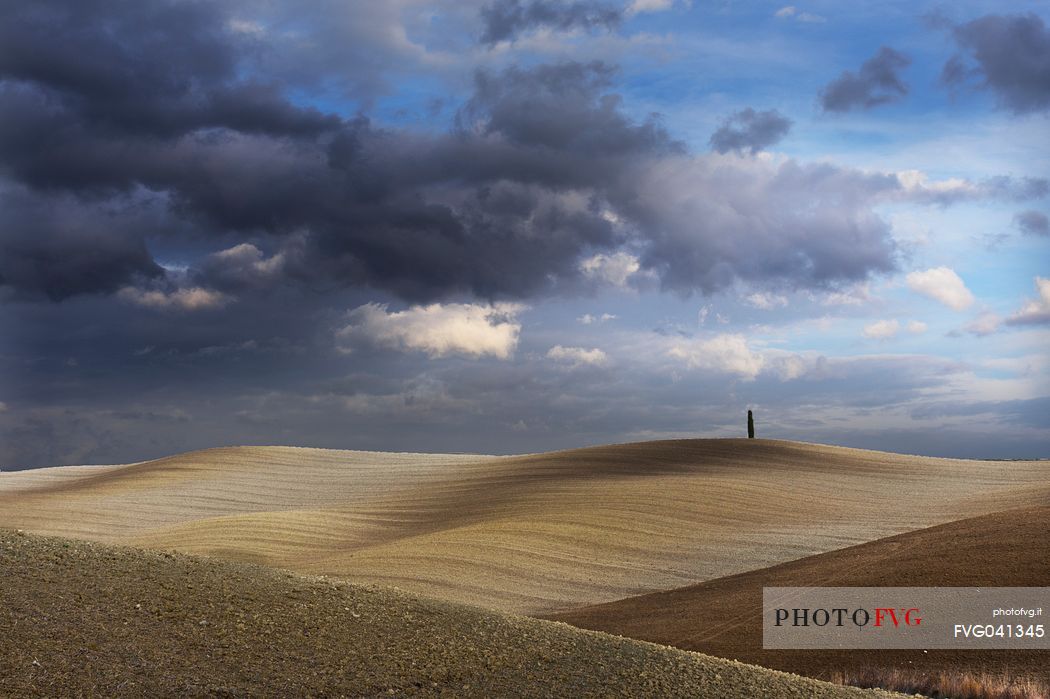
[{"xmin": 0, "ymin": 440, "xmax": 1050, "ymax": 613}]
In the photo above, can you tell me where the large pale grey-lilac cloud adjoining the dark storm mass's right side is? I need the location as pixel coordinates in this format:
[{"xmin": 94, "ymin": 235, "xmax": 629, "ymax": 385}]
[{"xmin": 629, "ymin": 157, "xmax": 899, "ymax": 293}]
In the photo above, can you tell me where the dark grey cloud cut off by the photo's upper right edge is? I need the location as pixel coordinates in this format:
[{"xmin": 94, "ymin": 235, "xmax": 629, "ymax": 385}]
[{"xmin": 941, "ymin": 14, "xmax": 1050, "ymax": 113}]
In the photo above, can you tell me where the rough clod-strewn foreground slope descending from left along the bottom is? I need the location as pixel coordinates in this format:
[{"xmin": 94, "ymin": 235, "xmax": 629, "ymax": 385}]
[{"xmin": 0, "ymin": 530, "xmax": 907, "ymax": 699}]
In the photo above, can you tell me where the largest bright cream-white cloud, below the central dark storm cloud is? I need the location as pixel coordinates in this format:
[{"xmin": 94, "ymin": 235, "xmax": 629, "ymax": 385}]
[{"xmin": 336, "ymin": 303, "xmax": 524, "ymax": 359}]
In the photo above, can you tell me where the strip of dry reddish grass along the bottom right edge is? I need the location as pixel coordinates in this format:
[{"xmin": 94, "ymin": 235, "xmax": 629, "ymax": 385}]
[{"xmin": 832, "ymin": 668, "xmax": 1050, "ymax": 699}]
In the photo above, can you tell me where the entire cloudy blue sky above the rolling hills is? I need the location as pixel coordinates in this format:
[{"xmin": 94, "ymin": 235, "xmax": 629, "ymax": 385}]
[{"xmin": 0, "ymin": 0, "xmax": 1050, "ymax": 470}]
